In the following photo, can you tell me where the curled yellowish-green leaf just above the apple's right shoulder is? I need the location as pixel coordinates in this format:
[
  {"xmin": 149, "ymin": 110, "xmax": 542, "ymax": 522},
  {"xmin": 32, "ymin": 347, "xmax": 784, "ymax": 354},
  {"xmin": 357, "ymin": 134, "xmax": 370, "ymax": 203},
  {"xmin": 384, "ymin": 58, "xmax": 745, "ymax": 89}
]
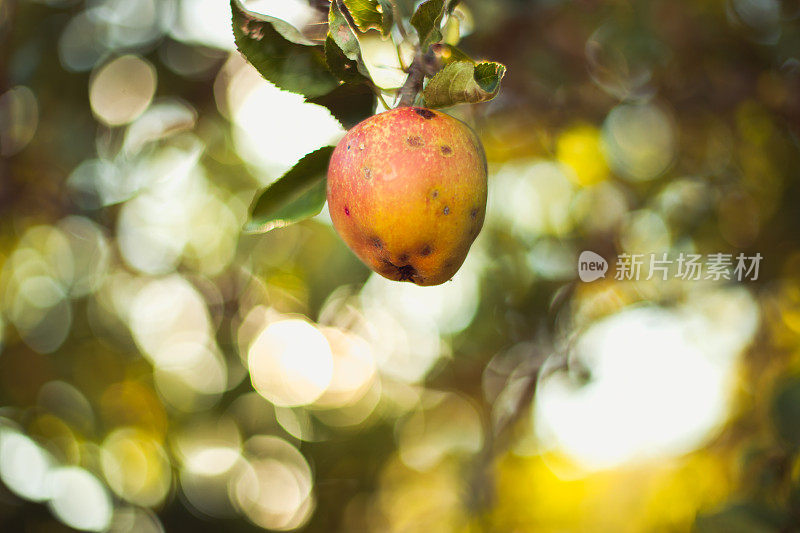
[{"xmin": 422, "ymin": 61, "xmax": 506, "ymax": 107}]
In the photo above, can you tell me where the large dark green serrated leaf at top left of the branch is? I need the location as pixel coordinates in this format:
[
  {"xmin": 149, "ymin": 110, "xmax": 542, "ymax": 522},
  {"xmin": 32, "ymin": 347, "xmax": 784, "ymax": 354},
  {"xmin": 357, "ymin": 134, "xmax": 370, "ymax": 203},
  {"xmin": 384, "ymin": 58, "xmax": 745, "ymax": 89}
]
[{"xmin": 231, "ymin": 0, "xmax": 339, "ymax": 98}]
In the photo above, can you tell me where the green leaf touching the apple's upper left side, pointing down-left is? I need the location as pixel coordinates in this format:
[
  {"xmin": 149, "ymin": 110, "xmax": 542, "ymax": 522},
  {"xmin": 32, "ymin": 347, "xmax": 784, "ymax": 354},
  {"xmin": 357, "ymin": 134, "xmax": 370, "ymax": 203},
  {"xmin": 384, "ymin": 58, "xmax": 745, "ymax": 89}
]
[{"xmin": 244, "ymin": 146, "xmax": 333, "ymax": 233}]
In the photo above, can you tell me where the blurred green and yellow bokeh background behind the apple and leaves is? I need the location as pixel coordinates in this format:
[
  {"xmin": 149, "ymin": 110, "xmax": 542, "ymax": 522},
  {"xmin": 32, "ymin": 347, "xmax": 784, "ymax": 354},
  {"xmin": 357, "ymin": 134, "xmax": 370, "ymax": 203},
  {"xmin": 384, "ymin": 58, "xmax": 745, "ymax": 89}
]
[{"xmin": 0, "ymin": 0, "xmax": 800, "ymax": 533}]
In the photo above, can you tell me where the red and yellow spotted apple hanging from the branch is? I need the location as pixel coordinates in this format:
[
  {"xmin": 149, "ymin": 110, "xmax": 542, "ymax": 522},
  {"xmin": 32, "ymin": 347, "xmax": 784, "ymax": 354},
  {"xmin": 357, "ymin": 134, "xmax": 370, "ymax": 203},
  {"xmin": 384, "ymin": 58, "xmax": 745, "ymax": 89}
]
[{"xmin": 327, "ymin": 107, "xmax": 487, "ymax": 285}]
